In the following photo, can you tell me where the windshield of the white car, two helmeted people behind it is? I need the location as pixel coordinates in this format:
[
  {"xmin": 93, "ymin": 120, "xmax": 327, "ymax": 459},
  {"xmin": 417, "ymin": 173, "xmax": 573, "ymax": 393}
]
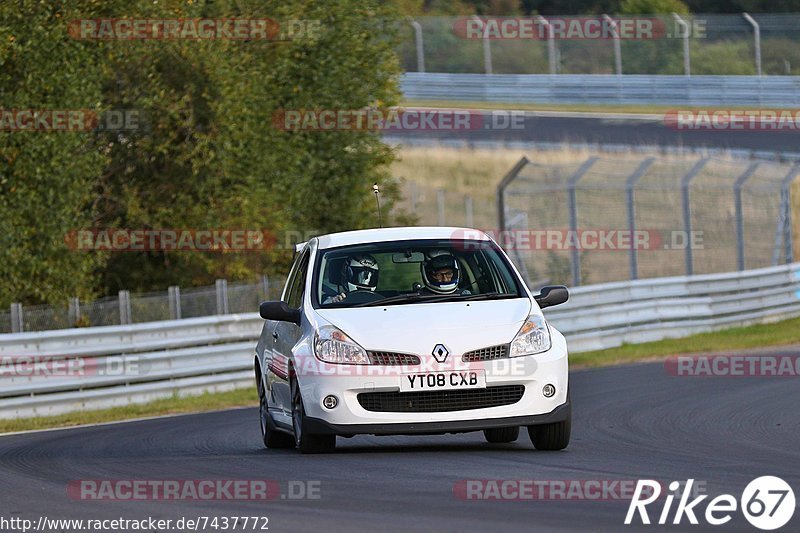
[{"xmin": 313, "ymin": 240, "xmax": 525, "ymax": 308}]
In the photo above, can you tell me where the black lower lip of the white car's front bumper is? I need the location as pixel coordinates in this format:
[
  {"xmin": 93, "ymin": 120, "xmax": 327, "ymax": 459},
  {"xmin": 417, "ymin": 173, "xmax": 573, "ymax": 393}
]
[{"xmin": 305, "ymin": 401, "xmax": 571, "ymax": 437}]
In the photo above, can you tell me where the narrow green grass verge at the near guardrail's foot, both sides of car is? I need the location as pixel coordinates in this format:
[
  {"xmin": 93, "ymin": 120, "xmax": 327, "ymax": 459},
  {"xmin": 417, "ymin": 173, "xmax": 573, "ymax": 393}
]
[{"xmin": 0, "ymin": 318, "xmax": 800, "ymax": 433}]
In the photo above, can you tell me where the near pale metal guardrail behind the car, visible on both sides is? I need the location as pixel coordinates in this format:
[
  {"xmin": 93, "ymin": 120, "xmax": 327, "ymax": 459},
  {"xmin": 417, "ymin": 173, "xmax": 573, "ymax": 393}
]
[{"xmin": 0, "ymin": 263, "xmax": 800, "ymax": 419}]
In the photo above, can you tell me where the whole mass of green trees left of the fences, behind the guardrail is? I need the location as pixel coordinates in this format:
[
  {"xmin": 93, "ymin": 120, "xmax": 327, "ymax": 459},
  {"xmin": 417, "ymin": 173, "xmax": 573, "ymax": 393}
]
[{"xmin": 0, "ymin": 0, "xmax": 399, "ymax": 304}]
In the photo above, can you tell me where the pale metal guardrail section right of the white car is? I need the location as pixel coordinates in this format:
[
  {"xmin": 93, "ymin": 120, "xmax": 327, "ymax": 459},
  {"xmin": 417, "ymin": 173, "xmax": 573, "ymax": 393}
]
[{"xmin": 545, "ymin": 263, "xmax": 800, "ymax": 352}]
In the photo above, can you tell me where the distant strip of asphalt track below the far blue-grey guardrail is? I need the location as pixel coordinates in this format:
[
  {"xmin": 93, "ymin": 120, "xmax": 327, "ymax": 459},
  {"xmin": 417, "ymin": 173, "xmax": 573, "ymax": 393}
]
[{"xmin": 388, "ymin": 112, "xmax": 800, "ymax": 153}]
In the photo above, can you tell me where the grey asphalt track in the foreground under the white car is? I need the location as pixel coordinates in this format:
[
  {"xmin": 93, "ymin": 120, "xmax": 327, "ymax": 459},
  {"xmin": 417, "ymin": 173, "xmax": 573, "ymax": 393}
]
[{"xmin": 0, "ymin": 363, "xmax": 800, "ymax": 531}]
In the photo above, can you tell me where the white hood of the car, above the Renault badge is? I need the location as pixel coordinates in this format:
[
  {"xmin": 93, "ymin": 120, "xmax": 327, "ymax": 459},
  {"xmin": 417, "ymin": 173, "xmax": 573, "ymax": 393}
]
[{"xmin": 316, "ymin": 298, "xmax": 532, "ymax": 356}]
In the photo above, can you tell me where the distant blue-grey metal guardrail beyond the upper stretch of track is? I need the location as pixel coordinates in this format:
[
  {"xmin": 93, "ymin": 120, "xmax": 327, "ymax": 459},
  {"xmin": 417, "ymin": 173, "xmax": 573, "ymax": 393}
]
[{"xmin": 400, "ymin": 72, "xmax": 800, "ymax": 109}]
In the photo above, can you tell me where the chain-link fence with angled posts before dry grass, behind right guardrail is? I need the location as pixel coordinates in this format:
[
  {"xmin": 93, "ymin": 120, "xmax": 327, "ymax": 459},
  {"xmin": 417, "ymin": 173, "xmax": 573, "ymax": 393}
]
[{"xmin": 496, "ymin": 156, "xmax": 800, "ymax": 287}]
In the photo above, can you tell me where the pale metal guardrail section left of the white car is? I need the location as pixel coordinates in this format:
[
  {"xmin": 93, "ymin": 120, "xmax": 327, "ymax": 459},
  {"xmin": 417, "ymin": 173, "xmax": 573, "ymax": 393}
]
[{"xmin": 0, "ymin": 314, "xmax": 264, "ymax": 419}]
